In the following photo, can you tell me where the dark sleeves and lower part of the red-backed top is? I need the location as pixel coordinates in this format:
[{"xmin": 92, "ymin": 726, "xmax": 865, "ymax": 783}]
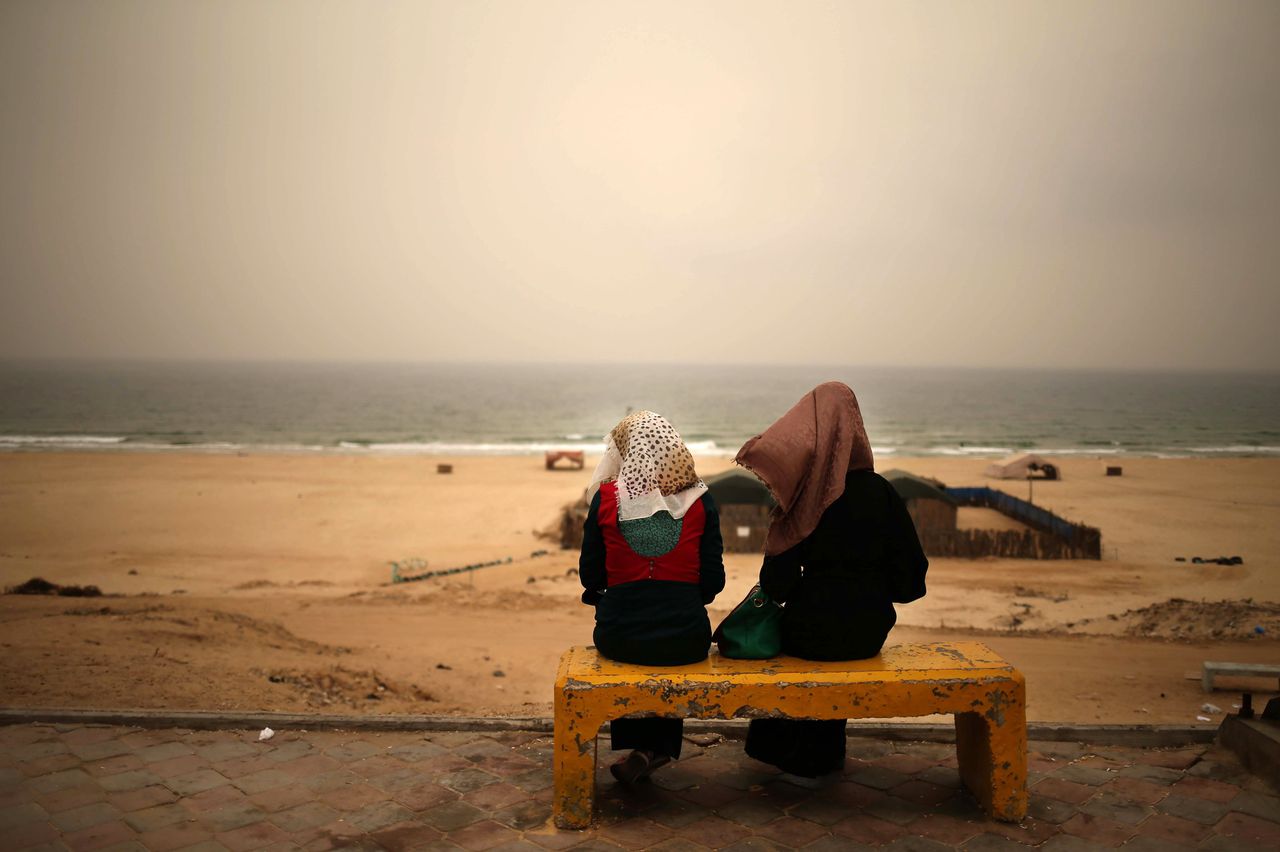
[{"xmin": 577, "ymin": 493, "xmax": 724, "ymax": 665}]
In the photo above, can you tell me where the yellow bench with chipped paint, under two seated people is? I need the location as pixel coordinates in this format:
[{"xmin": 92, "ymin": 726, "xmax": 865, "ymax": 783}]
[{"xmin": 554, "ymin": 642, "xmax": 1027, "ymax": 828}]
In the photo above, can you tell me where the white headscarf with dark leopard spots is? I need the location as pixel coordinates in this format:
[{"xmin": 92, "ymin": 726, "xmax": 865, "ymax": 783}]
[{"xmin": 588, "ymin": 411, "xmax": 707, "ymax": 521}]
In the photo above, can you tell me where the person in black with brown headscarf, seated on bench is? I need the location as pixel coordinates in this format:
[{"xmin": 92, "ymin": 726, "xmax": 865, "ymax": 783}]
[{"xmin": 737, "ymin": 381, "xmax": 928, "ymax": 778}]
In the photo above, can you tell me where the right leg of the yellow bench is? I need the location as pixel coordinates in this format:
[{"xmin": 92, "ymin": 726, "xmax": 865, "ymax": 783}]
[{"xmin": 956, "ymin": 701, "xmax": 1027, "ymax": 823}]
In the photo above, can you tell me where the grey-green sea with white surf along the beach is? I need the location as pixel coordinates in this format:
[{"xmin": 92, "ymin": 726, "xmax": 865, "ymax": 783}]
[{"xmin": 0, "ymin": 362, "xmax": 1280, "ymax": 457}]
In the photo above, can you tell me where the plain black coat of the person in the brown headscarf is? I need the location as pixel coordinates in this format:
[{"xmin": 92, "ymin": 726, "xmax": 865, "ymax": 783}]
[{"xmin": 760, "ymin": 471, "xmax": 929, "ymax": 660}]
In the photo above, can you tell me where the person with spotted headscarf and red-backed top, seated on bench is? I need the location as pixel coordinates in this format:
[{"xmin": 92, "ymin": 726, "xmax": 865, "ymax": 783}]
[{"xmin": 579, "ymin": 411, "xmax": 724, "ymax": 783}]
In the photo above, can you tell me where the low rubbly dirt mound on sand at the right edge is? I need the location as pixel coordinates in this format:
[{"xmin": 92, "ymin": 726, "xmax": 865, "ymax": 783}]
[{"xmin": 1117, "ymin": 597, "xmax": 1280, "ymax": 641}]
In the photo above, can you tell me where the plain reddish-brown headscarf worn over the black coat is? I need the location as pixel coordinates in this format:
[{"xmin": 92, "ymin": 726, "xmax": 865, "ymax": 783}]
[{"xmin": 733, "ymin": 381, "xmax": 876, "ymax": 556}]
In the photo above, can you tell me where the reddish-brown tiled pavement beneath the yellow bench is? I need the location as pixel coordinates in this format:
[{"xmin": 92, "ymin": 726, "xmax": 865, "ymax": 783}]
[{"xmin": 0, "ymin": 725, "xmax": 1280, "ymax": 852}]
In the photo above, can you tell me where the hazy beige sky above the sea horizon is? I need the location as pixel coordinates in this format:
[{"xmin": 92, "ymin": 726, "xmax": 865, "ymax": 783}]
[{"xmin": 0, "ymin": 0, "xmax": 1280, "ymax": 370}]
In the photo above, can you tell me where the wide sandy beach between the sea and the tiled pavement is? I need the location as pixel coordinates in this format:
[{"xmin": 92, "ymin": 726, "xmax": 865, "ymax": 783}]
[{"xmin": 0, "ymin": 453, "xmax": 1280, "ymax": 724}]
